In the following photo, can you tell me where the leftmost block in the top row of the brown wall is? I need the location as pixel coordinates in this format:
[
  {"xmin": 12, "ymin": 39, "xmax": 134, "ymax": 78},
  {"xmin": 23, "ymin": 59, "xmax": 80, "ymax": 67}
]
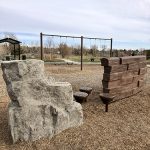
[{"xmin": 101, "ymin": 57, "xmax": 120, "ymax": 66}]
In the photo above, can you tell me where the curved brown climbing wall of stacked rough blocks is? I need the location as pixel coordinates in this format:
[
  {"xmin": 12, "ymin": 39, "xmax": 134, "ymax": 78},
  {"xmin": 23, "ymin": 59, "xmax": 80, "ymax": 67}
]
[{"xmin": 102, "ymin": 56, "xmax": 147, "ymax": 103}]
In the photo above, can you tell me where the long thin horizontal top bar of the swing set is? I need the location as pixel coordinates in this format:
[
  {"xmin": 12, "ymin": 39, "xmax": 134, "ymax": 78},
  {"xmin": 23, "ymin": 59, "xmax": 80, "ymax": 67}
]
[{"xmin": 41, "ymin": 33, "xmax": 112, "ymax": 40}]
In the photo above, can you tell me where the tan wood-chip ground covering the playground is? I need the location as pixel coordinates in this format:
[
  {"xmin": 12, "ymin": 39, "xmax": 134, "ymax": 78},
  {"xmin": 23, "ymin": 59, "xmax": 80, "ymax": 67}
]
[{"xmin": 0, "ymin": 65, "xmax": 150, "ymax": 150}]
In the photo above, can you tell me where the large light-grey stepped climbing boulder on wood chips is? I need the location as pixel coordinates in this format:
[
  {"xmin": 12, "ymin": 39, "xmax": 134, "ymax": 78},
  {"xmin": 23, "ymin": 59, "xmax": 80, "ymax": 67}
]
[{"xmin": 1, "ymin": 60, "xmax": 83, "ymax": 143}]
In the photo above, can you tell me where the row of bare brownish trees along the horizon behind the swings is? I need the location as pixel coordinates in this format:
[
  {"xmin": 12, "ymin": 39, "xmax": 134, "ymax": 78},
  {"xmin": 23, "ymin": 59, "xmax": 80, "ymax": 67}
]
[{"xmin": 0, "ymin": 33, "xmax": 150, "ymax": 58}]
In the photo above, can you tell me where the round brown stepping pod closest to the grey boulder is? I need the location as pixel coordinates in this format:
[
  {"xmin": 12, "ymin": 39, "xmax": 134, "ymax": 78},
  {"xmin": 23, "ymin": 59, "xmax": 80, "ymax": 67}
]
[{"xmin": 73, "ymin": 92, "xmax": 88, "ymax": 103}]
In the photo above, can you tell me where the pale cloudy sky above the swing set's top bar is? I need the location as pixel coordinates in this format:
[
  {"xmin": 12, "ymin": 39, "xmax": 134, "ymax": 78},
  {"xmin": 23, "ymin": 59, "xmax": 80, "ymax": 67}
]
[{"xmin": 0, "ymin": 0, "xmax": 150, "ymax": 48}]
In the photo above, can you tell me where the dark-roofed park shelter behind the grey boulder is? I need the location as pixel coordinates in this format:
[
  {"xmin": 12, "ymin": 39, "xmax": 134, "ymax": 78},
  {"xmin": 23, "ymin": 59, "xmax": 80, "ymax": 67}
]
[{"xmin": 0, "ymin": 38, "xmax": 21, "ymax": 60}]
